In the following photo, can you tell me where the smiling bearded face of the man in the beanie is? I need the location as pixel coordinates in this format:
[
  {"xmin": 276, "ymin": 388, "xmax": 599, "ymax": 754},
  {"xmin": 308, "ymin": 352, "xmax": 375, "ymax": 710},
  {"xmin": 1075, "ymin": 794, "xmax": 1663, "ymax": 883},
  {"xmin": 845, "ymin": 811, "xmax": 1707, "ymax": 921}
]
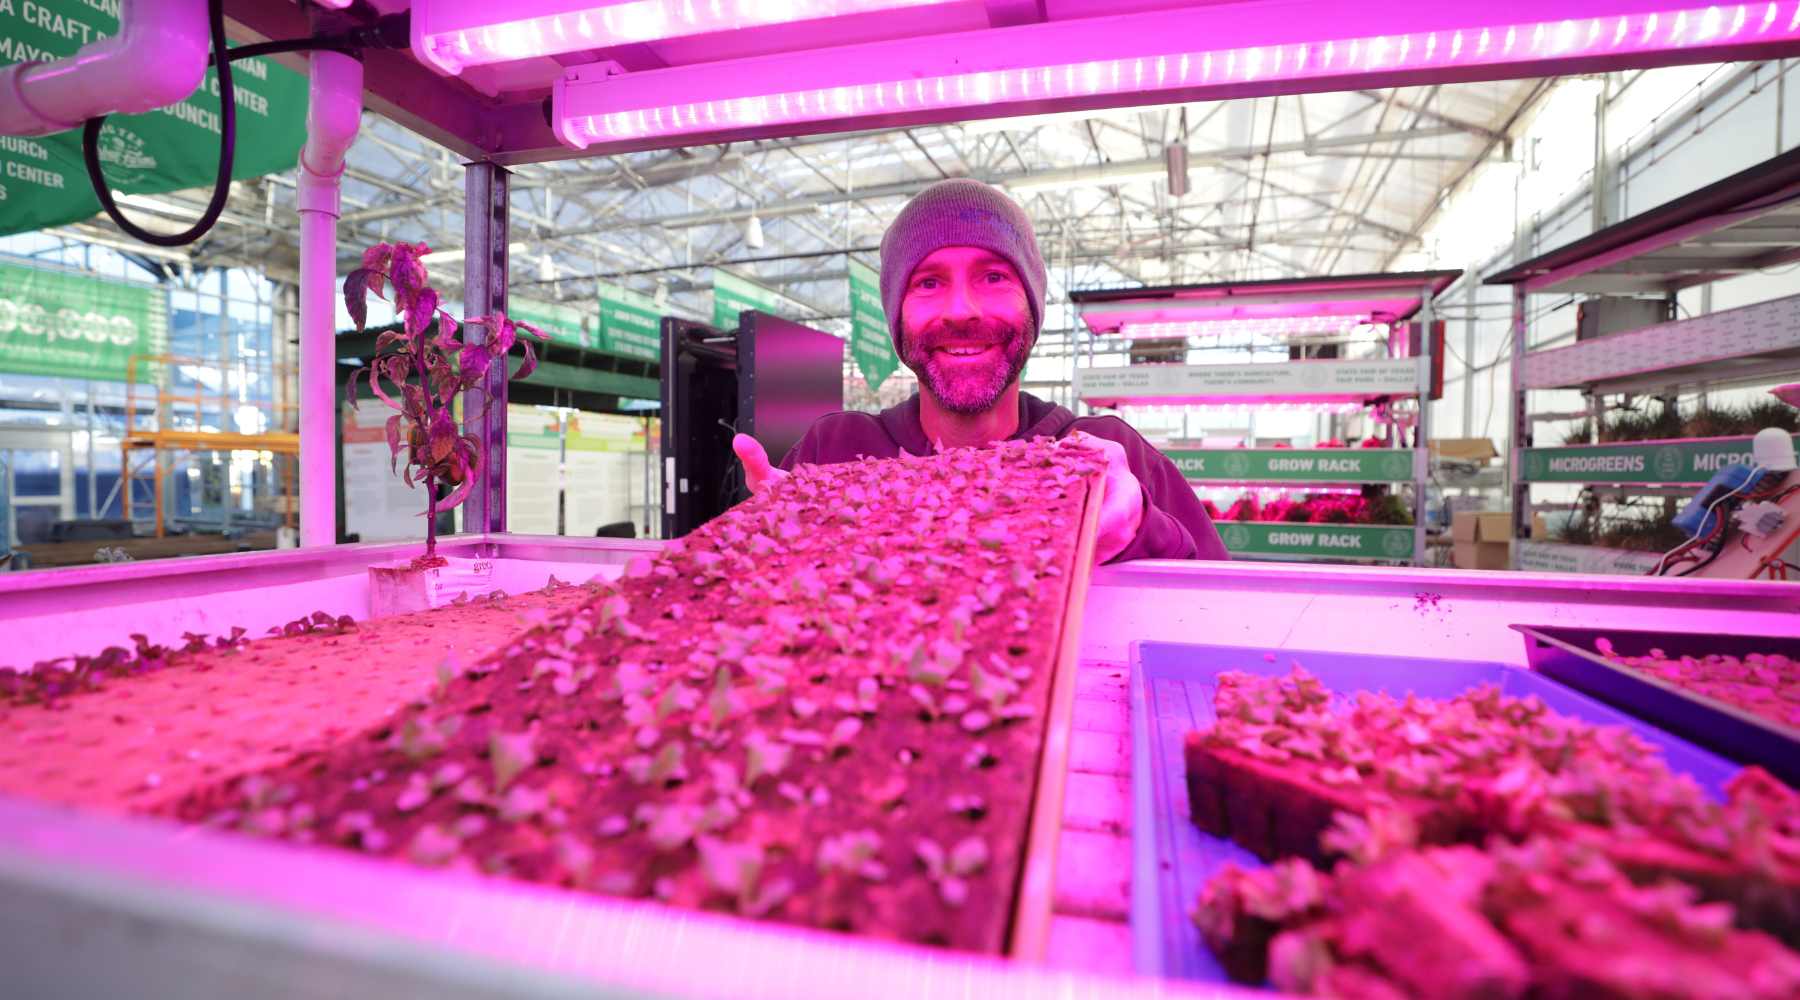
[{"xmin": 900, "ymin": 246, "xmax": 1037, "ymax": 415}]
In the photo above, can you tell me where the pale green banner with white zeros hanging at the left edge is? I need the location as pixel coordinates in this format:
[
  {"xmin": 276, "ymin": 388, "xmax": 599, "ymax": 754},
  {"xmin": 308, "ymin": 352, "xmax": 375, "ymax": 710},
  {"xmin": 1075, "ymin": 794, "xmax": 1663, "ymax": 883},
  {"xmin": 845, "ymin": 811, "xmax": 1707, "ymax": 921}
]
[{"xmin": 0, "ymin": 258, "xmax": 169, "ymax": 381}]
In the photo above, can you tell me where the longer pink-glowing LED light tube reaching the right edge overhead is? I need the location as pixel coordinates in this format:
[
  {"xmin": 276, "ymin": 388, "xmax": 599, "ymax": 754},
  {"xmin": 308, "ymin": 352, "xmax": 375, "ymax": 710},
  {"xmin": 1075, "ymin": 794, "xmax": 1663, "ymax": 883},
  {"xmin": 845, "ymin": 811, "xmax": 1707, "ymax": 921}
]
[{"xmin": 553, "ymin": 2, "xmax": 1800, "ymax": 149}]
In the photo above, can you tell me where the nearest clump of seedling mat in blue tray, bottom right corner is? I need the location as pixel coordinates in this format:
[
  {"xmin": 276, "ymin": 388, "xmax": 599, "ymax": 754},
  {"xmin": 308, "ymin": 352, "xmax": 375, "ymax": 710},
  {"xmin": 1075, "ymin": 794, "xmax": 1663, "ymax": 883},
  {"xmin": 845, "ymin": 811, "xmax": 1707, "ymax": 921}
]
[{"xmin": 1193, "ymin": 826, "xmax": 1800, "ymax": 1000}]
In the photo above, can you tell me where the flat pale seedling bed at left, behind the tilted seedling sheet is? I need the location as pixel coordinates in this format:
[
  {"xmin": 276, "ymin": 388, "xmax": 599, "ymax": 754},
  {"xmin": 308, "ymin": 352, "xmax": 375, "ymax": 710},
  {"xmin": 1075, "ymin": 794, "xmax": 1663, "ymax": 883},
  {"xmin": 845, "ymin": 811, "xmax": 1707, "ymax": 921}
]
[{"xmin": 0, "ymin": 585, "xmax": 592, "ymax": 811}]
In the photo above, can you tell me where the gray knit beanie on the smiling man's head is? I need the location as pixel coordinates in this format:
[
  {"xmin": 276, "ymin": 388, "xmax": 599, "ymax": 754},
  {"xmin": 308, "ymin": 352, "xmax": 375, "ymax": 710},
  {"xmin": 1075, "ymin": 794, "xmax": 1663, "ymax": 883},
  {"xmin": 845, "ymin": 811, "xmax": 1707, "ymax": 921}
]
[{"xmin": 882, "ymin": 178, "xmax": 1046, "ymax": 351}]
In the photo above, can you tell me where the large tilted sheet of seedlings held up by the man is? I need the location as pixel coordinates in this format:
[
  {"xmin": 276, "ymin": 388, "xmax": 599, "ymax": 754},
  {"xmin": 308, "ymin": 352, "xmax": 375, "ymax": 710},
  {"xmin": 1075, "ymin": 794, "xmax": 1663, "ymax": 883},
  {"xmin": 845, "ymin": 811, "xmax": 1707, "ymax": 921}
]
[{"xmin": 167, "ymin": 441, "xmax": 1103, "ymax": 951}]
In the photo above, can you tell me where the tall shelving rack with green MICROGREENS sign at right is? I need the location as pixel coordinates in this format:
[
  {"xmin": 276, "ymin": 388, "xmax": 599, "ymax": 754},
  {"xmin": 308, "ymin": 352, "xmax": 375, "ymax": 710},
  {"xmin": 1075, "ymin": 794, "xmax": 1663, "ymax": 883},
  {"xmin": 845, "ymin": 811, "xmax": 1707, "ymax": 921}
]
[{"xmin": 1485, "ymin": 142, "xmax": 1800, "ymax": 574}]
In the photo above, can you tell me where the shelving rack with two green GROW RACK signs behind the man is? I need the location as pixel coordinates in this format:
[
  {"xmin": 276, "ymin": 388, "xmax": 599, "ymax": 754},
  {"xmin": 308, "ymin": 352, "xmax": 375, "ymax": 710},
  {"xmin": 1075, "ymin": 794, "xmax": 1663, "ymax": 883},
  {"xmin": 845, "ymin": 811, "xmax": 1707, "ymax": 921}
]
[{"xmin": 1069, "ymin": 270, "xmax": 1462, "ymax": 565}]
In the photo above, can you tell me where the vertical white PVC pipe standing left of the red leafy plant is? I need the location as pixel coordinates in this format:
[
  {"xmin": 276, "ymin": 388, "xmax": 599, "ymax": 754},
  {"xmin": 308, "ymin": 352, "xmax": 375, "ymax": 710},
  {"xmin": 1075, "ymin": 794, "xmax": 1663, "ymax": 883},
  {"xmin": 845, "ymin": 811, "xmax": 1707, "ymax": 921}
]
[{"xmin": 297, "ymin": 52, "xmax": 362, "ymax": 545}]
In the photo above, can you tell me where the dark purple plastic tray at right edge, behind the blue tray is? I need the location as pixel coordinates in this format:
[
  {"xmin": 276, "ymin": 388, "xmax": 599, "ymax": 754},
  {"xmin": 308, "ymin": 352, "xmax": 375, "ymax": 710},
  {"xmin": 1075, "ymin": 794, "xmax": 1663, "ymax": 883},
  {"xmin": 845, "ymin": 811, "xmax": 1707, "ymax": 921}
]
[{"xmin": 1512, "ymin": 624, "xmax": 1800, "ymax": 788}]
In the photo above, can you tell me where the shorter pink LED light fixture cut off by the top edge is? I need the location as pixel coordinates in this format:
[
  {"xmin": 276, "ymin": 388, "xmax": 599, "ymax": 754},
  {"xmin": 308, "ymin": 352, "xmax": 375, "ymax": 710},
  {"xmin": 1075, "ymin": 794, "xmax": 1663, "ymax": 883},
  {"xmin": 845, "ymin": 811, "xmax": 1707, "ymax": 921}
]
[{"xmin": 412, "ymin": 0, "xmax": 958, "ymax": 76}]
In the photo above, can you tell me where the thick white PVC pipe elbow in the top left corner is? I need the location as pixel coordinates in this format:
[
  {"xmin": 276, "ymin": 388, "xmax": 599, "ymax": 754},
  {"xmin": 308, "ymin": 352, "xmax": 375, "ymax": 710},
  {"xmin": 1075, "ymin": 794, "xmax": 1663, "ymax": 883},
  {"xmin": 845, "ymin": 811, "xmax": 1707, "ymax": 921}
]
[{"xmin": 0, "ymin": 0, "xmax": 211, "ymax": 135}]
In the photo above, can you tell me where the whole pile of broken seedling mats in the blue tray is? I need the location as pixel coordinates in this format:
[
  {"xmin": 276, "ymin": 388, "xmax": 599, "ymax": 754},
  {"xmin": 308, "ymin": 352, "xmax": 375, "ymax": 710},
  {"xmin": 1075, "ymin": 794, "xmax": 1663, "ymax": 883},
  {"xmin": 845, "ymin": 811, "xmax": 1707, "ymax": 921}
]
[{"xmin": 1186, "ymin": 665, "xmax": 1800, "ymax": 996}]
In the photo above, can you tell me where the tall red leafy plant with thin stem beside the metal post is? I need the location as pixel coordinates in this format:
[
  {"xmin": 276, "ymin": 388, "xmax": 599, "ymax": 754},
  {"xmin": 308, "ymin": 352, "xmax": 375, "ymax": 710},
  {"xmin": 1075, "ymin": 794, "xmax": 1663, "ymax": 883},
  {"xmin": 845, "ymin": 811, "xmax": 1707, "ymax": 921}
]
[{"xmin": 344, "ymin": 243, "xmax": 547, "ymax": 567}]
